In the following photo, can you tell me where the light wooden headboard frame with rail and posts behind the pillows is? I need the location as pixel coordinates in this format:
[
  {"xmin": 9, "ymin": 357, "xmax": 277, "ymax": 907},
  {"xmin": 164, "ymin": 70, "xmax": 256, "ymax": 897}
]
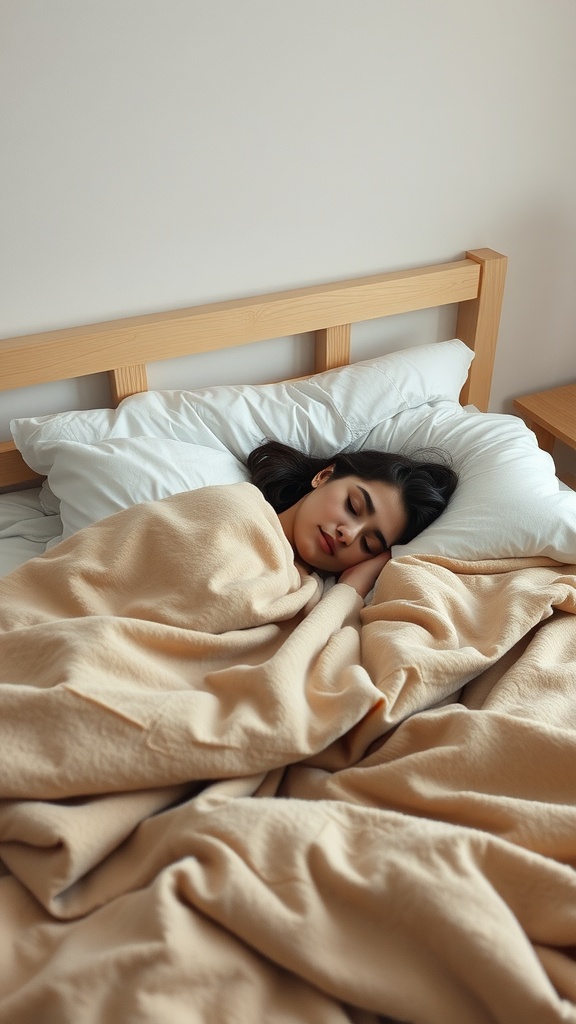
[{"xmin": 0, "ymin": 249, "xmax": 507, "ymax": 490}]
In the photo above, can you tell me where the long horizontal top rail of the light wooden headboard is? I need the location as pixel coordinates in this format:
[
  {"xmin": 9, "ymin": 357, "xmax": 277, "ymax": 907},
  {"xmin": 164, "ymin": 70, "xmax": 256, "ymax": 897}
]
[{"xmin": 0, "ymin": 259, "xmax": 480, "ymax": 389}]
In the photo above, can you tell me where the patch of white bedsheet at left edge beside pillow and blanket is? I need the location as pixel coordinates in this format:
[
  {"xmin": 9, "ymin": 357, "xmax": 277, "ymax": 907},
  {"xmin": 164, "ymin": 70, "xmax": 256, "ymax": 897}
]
[{"xmin": 0, "ymin": 487, "xmax": 61, "ymax": 575}]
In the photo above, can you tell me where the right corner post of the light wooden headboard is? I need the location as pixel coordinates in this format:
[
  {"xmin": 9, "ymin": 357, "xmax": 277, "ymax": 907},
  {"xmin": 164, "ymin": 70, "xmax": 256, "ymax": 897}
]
[{"xmin": 456, "ymin": 249, "xmax": 508, "ymax": 413}]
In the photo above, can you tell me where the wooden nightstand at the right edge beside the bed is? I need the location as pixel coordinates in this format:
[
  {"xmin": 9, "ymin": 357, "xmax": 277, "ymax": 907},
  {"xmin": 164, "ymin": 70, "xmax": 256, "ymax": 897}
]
[{"xmin": 515, "ymin": 384, "xmax": 576, "ymax": 489}]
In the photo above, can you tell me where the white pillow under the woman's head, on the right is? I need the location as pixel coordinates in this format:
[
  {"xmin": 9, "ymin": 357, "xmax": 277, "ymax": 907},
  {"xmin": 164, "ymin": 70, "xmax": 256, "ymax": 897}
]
[{"xmin": 365, "ymin": 401, "xmax": 576, "ymax": 562}]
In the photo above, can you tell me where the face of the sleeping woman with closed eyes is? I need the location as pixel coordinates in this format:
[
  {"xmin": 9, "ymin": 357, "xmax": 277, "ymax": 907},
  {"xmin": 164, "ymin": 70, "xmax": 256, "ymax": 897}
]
[{"xmin": 280, "ymin": 466, "xmax": 407, "ymax": 574}]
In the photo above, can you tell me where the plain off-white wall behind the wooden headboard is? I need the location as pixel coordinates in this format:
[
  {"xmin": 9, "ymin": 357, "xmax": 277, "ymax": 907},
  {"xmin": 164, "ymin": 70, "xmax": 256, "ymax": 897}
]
[{"xmin": 0, "ymin": 0, "xmax": 576, "ymax": 468}]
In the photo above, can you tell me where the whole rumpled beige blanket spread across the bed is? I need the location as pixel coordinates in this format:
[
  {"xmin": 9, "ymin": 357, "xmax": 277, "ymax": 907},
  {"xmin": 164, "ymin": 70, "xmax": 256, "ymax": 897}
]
[{"xmin": 0, "ymin": 484, "xmax": 576, "ymax": 1024}]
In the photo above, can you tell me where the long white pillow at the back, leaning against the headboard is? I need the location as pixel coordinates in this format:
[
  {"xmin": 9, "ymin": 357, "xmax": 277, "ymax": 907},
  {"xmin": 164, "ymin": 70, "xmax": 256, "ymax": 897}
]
[{"xmin": 10, "ymin": 339, "xmax": 474, "ymax": 468}]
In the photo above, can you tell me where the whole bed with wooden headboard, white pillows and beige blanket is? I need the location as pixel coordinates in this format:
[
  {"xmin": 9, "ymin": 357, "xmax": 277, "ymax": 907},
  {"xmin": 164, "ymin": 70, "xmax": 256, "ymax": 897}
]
[{"xmin": 0, "ymin": 249, "xmax": 576, "ymax": 1024}]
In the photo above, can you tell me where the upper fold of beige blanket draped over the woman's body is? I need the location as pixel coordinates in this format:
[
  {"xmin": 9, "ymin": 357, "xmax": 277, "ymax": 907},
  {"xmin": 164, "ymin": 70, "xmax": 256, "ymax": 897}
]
[{"xmin": 0, "ymin": 484, "xmax": 380, "ymax": 800}]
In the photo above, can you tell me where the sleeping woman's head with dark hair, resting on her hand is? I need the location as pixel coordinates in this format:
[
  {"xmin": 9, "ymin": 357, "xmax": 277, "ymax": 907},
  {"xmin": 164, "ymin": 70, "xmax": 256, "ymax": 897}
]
[{"xmin": 248, "ymin": 441, "xmax": 458, "ymax": 597}]
